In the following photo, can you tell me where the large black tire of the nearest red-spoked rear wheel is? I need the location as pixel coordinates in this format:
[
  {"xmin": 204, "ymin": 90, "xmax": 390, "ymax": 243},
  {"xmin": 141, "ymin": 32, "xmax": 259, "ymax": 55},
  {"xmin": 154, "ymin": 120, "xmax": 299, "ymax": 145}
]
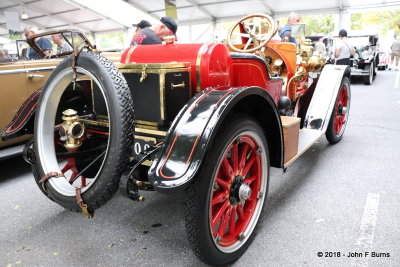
[{"xmin": 184, "ymin": 115, "xmax": 269, "ymax": 265}]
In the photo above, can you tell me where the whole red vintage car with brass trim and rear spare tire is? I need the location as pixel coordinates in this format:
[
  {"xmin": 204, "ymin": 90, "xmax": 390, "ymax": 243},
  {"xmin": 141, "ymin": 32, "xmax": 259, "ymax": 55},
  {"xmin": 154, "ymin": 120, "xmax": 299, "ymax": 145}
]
[{"xmin": 1, "ymin": 14, "xmax": 350, "ymax": 265}]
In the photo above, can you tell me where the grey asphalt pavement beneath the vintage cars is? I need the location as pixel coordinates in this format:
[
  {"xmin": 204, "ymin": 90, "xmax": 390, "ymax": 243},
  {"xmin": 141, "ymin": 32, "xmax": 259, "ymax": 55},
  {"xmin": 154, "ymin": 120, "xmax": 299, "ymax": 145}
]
[{"xmin": 0, "ymin": 70, "xmax": 400, "ymax": 267}]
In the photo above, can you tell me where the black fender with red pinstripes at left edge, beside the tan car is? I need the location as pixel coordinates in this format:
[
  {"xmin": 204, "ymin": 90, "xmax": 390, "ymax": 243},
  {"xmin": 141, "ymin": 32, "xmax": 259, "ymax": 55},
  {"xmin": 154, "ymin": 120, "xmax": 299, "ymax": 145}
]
[{"xmin": 0, "ymin": 88, "xmax": 42, "ymax": 141}]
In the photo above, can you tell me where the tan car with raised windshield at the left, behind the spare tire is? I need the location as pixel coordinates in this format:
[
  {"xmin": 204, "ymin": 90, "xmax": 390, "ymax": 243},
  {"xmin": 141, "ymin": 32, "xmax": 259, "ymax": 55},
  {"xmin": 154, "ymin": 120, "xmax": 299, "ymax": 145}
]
[{"xmin": 0, "ymin": 30, "xmax": 108, "ymax": 160}]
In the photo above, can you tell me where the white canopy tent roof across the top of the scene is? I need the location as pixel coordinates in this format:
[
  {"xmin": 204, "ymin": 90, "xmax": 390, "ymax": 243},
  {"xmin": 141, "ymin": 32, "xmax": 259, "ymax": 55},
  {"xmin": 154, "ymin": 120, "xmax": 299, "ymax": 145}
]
[{"xmin": 0, "ymin": 0, "xmax": 400, "ymax": 45}]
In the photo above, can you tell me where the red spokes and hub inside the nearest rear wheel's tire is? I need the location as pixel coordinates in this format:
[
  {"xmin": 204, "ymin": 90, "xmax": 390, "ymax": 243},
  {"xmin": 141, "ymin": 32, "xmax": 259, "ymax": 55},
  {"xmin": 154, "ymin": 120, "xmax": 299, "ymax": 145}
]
[{"xmin": 210, "ymin": 135, "xmax": 263, "ymax": 247}]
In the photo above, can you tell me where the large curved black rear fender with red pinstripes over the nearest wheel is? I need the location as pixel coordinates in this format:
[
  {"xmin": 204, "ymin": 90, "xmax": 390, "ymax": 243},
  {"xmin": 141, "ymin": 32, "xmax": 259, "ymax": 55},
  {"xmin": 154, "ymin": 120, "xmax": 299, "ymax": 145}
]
[{"xmin": 148, "ymin": 87, "xmax": 284, "ymax": 193}]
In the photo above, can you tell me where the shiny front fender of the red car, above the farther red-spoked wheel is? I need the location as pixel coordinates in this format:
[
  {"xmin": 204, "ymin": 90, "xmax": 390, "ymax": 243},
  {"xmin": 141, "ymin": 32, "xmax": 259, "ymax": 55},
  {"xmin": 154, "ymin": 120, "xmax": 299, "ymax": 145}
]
[{"xmin": 304, "ymin": 65, "xmax": 350, "ymax": 132}]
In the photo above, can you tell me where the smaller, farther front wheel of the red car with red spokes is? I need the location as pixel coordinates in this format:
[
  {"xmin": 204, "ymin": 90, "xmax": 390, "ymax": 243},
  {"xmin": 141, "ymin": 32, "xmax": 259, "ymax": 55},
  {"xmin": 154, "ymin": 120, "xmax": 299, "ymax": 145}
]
[{"xmin": 325, "ymin": 77, "xmax": 351, "ymax": 144}]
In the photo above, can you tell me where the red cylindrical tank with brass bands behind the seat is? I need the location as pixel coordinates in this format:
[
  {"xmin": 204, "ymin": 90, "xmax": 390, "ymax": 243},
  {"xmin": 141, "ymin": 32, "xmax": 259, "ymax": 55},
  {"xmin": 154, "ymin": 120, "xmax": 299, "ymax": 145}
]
[{"xmin": 120, "ymin": 44, "xmax": 232, "ymax": 95}]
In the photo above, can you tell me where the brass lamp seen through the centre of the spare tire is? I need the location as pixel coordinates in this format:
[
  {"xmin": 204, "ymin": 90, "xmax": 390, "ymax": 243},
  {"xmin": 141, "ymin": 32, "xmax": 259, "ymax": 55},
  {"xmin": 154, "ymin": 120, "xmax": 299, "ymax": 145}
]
[{"xmin": 62, "ymin": 109, "xmax": 85, "ymax": 150}]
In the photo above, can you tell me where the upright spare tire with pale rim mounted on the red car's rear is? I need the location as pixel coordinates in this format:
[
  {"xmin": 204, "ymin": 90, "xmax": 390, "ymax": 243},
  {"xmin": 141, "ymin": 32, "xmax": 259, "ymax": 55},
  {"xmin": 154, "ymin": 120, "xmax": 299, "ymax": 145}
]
[{"xmin": 32, "ymin": 51, "xmax": 134, "ymax": 214}]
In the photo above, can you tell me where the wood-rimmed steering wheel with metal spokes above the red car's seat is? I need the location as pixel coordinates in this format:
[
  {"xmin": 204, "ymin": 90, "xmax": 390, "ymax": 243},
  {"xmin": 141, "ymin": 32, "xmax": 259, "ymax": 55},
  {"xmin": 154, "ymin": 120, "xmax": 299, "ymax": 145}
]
[{"xmin": 227, "ymin": 13, "xmax": 278, "ymax": 53}]
